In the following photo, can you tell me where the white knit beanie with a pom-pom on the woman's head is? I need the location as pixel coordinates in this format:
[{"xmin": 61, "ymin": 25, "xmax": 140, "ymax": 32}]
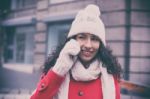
[{"xmin": 68, "ymin": 4, "xmax": 106, "ymax": 45}]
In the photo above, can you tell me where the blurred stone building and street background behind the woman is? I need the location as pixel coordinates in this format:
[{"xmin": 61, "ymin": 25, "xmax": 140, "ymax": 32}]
[{"xmin": 0, "ymin": 0, "xmax": 150, "ymax": 99}]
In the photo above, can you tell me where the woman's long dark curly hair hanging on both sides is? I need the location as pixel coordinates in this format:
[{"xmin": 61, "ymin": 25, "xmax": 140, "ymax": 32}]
[{"xmin": 43, "ymin": 36, "xmax": 122, "ymax": 79}]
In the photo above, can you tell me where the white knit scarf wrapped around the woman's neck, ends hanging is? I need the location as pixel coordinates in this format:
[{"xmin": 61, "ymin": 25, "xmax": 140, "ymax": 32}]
[{"xmin": 53, "ymin": 61, "xmax": 116, "ymax": 99}]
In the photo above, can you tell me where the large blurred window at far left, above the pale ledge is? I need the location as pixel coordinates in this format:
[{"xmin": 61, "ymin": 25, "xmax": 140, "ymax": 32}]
[{"xmin": 4, "ymin": 26, "xmax": 35, "ymax": 64}]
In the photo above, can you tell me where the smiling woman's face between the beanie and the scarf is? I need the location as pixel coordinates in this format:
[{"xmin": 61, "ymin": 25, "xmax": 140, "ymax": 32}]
[{"xmin": 76, "ymin": 33, "xmax": 100, "ymax": 63}]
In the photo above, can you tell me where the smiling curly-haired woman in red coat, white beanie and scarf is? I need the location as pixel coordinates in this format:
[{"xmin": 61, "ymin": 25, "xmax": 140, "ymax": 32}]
[{"xmin": 31, "ymin": 5, "xmax": 121, "ymax": 99}]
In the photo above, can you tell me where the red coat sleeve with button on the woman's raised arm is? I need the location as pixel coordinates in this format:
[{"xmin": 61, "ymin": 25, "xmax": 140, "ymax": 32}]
[{"xmin": 30, "ymin": 70, "xmax": 64, "ymax": 99}]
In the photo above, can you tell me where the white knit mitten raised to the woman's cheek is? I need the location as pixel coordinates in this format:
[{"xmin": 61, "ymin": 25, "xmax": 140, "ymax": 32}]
[{"xmin": 52, "ymin": 39, "xmax": 80, "ymax": 76}]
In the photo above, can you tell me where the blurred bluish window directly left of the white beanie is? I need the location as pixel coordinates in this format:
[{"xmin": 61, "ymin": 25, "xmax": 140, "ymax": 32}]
[{"xmin": 47, "ymin": 22, "xmax": 71, "ymax": 54}]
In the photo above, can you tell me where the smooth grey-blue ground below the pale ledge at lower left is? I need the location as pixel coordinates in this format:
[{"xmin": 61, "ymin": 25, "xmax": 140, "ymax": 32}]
[{"xmin": 0, "ymin": 67, "xmax": 40, "ymax": 90}]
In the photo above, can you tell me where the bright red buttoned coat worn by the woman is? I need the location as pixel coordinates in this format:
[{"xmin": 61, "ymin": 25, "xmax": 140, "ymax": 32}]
[{"xmin": 30, "ymin": 71, "xmax": 120, "ymax": 99}]
